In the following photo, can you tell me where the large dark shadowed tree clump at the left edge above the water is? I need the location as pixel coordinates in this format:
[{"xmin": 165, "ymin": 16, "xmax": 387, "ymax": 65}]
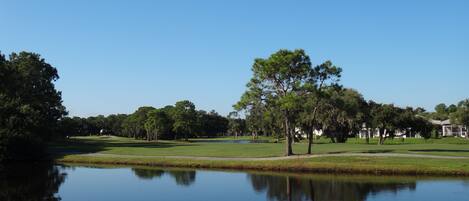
[{"xmin": 0, "ymin": 52, "xmax": 66, "ymax": 161}]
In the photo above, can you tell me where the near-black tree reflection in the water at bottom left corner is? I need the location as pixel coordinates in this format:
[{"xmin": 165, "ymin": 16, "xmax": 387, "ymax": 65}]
[{"xmin": 0, "ymin": 163, "xmax": 66, "ymax": 201}]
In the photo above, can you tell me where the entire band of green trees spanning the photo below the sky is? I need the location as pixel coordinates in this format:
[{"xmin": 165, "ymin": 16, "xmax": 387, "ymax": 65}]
[{"xmin": 0, "ymin": 49, "xmax": 469, "ymax": 161}]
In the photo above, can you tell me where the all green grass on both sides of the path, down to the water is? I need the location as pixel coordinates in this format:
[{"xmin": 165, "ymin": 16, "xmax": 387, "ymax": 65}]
[{"xmin": 50, "ymin": 137, "xmax": 469, "ymax": 176}]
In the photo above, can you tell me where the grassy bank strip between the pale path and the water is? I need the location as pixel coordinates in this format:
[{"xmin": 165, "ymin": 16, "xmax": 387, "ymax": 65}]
[{"xmin": 54, "ymin": 154, "xmax": 469, "ymax": 177}]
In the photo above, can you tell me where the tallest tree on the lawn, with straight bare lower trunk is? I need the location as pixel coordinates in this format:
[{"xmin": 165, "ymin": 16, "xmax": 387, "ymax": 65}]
[{"xmin": 236, "ymin": 49, "xmax": 336, "ymax": 155}]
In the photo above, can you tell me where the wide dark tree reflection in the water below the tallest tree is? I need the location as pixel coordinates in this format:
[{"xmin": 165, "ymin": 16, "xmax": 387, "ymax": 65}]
[{"xmin": 248, "ymin": 174, "xmax": 416, "ymax": 201}]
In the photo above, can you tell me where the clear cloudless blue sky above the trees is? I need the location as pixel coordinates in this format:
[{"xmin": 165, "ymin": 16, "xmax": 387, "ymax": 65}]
[{"xmin": 0, "ymin": 0, "xmax": 469, "ymax": 116}]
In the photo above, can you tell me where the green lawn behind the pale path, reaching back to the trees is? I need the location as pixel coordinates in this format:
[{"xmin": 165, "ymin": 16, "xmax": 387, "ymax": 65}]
[{"xmin": 51, "ymin": 136, "xmax": 469, "ymax": 157}]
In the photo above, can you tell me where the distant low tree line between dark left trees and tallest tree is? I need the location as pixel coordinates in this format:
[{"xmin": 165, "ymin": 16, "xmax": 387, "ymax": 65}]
[{"xmin": 61, "ymin": 100, "xmax": 230, "ymax": 141}]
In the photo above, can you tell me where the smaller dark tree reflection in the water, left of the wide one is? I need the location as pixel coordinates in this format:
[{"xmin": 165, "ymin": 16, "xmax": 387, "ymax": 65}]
[{"xmin": 132, "ymin": 168, "xmax": 196, "ymax": 186}]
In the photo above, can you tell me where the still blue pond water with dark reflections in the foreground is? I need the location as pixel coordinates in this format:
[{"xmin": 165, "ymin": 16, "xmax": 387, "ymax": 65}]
[{"xmin": 0, "ymin": 164, "xmax": 469, "ymax": 201}]
